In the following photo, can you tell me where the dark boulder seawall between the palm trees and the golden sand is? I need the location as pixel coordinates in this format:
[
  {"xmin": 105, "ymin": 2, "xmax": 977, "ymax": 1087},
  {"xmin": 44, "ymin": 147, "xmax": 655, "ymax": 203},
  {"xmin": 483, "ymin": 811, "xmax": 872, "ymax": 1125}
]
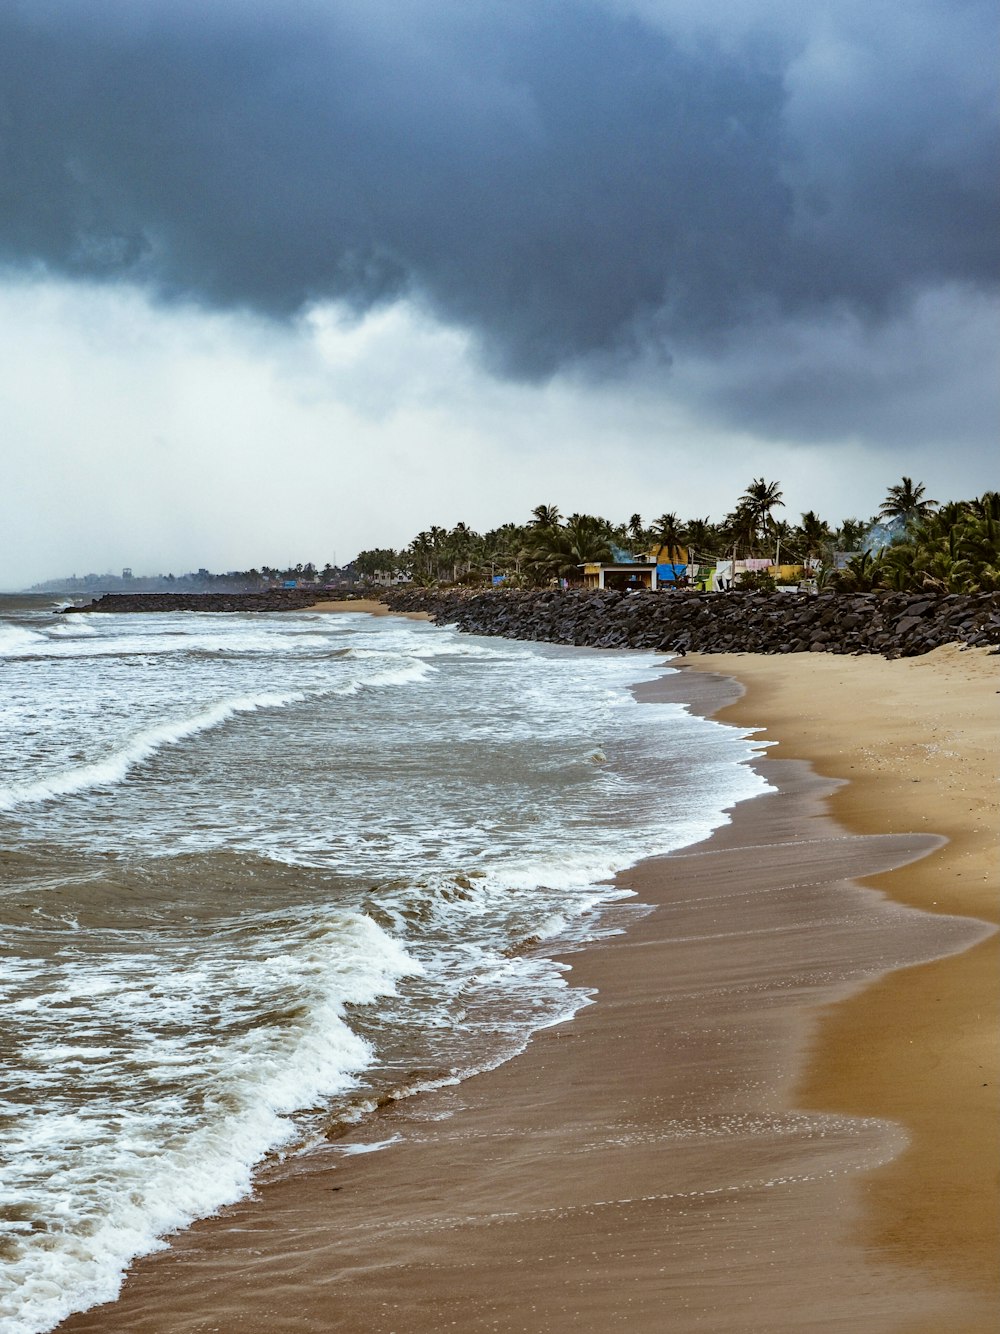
[{"xmin": 383, "ymin": 588, "xmax": 1000, "ymax": 658}]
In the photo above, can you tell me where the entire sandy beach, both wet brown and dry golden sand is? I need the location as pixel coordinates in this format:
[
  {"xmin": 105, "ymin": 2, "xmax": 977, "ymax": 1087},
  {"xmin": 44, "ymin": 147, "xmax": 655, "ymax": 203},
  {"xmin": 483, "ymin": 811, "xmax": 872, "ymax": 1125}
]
[{"xmin": 60, "ymin": 640, "xmax": 1000, "ymax": 1334}]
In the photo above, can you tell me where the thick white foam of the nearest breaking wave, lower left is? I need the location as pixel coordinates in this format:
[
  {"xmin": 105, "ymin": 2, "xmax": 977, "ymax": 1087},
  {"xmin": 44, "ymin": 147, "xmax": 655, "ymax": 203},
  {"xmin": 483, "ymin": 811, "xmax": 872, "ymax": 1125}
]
[{"xmin": 0, "ymin": 914, "xmax": 420, "ymax": 1334}]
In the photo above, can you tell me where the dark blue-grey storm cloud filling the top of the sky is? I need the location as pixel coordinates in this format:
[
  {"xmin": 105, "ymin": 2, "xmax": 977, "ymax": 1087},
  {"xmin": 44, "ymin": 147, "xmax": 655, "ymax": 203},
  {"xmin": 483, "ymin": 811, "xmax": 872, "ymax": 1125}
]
[{"xmin": 0, "ymin": 0, "xmax": 997, "ymax": 376}]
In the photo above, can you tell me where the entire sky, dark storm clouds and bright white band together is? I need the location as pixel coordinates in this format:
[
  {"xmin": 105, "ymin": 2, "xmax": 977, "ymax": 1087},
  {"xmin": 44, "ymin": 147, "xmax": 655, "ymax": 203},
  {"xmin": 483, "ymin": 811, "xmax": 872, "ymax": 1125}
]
[{"xmin": 0, "ymin": 0, "xmax": 1000, "ymax": 588}]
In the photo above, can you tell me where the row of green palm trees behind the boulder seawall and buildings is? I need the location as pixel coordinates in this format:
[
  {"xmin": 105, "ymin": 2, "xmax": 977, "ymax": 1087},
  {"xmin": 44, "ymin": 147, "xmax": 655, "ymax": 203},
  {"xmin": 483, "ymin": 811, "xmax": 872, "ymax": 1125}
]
[{"xmin": 353, "ymin": 476, "xmax": 1000, "ymax": 592}]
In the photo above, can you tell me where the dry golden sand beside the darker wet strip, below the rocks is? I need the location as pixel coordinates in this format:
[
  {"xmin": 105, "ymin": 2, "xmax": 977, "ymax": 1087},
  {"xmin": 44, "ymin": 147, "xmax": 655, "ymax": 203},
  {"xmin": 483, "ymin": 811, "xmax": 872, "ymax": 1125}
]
[{"xmin": 683, "ymin": 646, "xmax": 1000, "ymax": 1301}]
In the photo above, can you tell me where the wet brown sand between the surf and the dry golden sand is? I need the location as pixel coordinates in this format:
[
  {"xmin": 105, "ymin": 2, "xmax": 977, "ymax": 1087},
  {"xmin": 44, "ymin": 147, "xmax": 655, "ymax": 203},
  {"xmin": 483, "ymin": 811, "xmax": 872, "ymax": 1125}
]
[{"xmin": 60, "ymin": 640, "xmax": 996, "ymax": 1334}]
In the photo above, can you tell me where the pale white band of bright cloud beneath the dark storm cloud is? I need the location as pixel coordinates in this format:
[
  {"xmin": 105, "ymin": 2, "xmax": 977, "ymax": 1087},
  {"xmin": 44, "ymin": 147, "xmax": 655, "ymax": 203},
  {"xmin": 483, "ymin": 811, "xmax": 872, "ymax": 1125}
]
[{"xmin": 0, "ymin": 279, "xmax": 987, "ymax": 588}]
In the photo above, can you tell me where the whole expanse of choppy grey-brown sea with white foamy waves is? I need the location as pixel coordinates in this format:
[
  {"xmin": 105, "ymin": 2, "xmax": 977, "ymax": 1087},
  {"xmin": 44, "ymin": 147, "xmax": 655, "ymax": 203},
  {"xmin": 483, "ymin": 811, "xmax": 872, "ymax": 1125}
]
[{"xmin": 0, "ymin": 596, "xmax": 765, "ymax": 1334}]
